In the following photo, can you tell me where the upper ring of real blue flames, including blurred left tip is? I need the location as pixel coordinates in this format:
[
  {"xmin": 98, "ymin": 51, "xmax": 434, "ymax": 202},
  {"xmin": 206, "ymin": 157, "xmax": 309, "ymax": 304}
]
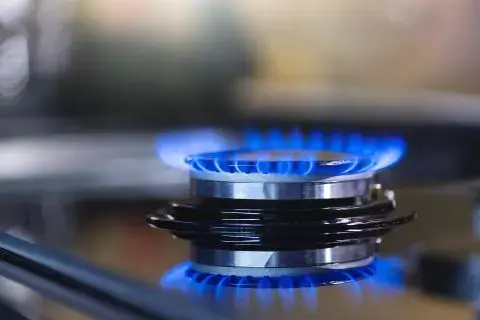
[{"xmin": 155, "ymin": 129, "xmax": 406, "ymax": 175}]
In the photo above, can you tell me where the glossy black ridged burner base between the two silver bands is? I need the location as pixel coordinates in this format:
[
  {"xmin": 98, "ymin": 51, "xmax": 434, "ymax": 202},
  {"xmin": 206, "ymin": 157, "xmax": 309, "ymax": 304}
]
[{"xmin": 147, "ymin": 199, "xmax": 415, "ymax": 251}]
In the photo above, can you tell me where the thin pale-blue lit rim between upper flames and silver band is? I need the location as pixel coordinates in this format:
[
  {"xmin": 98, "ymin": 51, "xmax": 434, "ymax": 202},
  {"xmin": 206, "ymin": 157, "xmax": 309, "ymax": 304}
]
[{"xmin": 190, "ymin": 170, "xmax": 375, "ymax": 183}]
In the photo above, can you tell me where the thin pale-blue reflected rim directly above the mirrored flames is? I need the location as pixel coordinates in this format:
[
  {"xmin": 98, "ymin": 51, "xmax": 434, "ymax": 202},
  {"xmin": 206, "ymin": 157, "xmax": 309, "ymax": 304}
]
[{"xmin": 192, "ymin": 255, "xmax": 375, "ymax": 277}]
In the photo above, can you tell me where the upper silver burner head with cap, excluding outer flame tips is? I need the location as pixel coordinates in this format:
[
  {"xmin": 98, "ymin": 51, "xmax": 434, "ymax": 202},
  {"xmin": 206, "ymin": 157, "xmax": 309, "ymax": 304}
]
[{"xmin": 187, "ymin": 150, "xmax": 373, "ymax": 200}]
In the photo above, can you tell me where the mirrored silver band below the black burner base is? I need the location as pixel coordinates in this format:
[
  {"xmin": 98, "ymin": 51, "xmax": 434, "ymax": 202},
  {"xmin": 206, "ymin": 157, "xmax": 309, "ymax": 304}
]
[{"xmin": 191, "ymin": 241, "xmax": 377, "ymax": 269}]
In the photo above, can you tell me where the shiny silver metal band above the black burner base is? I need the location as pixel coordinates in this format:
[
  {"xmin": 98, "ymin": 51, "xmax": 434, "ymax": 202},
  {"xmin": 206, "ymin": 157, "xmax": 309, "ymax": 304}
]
[{"xmin": 190, "ymin": 179, "xmax": 373, "ymax": 200}]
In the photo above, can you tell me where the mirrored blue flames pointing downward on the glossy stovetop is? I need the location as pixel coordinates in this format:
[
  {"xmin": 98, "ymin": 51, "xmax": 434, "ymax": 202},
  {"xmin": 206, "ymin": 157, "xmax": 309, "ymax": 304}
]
[{"xmin": 160, "ymin": 257, "xmax": 404, "ymax": 309}]
